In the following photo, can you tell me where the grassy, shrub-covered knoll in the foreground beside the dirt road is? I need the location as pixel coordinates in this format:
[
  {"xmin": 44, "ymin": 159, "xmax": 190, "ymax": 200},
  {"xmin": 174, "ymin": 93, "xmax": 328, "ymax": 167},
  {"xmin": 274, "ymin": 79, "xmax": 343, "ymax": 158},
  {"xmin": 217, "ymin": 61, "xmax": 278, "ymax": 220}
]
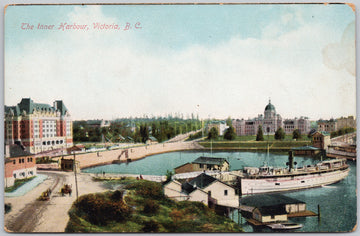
[{"xmin": 65, "ymin": 179, "xmax": 242, "ymax": 233}]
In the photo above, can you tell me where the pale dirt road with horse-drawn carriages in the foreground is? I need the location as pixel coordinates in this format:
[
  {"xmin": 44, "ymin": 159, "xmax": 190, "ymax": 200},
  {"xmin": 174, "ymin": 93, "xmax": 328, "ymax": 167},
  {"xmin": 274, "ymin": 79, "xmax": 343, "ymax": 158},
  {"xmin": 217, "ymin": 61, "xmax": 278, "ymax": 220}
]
[{"xmin": 4, "ymin": 172, "xmax": 106, "ymax": 232}]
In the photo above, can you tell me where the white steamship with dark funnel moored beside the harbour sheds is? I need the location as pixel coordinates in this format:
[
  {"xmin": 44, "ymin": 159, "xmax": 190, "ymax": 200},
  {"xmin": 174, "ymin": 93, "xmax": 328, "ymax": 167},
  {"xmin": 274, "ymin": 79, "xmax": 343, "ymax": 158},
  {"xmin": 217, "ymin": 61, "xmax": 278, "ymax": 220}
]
[{"xmin": 239, "ymin": 154, "xmax": 350, "ymax": 195}]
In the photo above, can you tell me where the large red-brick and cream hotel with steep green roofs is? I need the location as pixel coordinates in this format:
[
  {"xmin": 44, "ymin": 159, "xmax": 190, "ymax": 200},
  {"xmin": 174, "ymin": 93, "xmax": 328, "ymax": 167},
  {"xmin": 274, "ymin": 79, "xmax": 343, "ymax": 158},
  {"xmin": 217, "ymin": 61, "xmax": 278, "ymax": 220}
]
[{"xmin": 4, "ymin": 98, "xmax": 73, "ymax": 154}]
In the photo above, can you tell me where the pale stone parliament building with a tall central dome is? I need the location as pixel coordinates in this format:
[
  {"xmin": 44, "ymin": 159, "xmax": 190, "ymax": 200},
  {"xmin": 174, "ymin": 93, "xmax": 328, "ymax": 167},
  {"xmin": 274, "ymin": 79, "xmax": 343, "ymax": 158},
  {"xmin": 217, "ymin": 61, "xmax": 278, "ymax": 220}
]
[{"xmin": 232, "ymin": 100, "xmax": 310, "ymax": 136}]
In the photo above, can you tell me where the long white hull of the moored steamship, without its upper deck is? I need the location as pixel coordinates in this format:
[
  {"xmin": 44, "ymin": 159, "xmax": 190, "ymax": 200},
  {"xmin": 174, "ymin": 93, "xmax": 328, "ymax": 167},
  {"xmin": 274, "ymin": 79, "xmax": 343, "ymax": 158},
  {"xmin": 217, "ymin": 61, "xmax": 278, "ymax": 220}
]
[{"xmin": 241, "ymin": 168, "xmax": 350, "ymax": 195}]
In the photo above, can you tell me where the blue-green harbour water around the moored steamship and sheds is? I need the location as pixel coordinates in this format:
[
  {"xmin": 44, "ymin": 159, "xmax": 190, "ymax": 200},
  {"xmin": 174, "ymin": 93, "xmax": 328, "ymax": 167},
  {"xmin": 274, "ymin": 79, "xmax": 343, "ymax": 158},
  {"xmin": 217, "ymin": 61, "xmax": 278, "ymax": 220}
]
[{"xmin": 82, "ymin": 152, "xmax": 357, "ymax": 232}]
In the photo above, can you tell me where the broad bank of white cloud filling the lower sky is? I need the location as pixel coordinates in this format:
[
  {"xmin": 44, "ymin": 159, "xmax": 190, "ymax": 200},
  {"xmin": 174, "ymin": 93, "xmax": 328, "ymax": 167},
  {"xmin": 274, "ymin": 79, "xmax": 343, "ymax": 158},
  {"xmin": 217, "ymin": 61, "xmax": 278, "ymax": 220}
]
[{"xmin": 5, "ymin": 6, "xmax": 355, "ymax": 119}]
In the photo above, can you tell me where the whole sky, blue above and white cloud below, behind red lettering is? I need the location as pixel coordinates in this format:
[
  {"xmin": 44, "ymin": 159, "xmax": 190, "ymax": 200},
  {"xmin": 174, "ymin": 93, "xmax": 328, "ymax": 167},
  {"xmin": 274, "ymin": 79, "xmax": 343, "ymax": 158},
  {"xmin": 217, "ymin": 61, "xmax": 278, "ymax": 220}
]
[{"xmin": 4, "ymin": 4, "xmax": 356, "ymax": 120}]
